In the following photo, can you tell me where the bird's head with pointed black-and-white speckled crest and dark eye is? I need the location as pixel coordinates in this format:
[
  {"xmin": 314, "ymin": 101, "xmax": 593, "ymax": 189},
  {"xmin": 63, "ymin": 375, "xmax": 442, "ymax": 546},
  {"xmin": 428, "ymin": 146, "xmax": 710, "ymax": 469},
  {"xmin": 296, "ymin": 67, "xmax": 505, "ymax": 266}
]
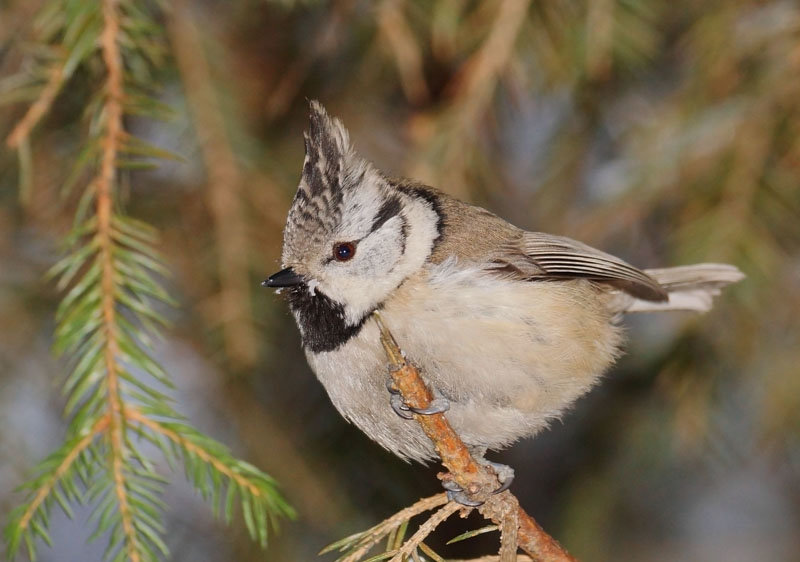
[{"xmin": 264, "ymin": 101, "xmax": 441, "ymax": 346}]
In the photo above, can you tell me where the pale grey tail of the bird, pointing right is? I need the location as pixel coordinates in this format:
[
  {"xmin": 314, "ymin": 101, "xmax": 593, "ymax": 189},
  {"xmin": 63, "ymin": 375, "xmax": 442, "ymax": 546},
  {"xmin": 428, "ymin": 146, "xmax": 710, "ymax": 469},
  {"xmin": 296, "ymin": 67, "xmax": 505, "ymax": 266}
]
[{"xmin": 624, "ymin": 263, "xmax": 745, "ymax": 312}]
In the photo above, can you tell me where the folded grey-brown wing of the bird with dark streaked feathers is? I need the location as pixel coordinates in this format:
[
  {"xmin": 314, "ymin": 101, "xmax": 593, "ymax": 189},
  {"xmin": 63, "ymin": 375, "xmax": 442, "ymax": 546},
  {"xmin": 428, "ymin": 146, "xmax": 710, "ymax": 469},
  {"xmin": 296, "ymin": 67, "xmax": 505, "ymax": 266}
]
[{"xmin": 490, "ymin": 232, "xmax": 668, "ymax": 301}]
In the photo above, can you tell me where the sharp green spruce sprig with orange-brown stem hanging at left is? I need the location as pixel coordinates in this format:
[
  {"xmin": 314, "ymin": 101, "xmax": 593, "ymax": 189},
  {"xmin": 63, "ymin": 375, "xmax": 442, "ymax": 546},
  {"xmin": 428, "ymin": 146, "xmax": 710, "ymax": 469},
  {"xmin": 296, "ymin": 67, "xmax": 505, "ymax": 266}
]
[{"xmin": 5, "ymin": 0, "xmax": 292, "ymax": 562}]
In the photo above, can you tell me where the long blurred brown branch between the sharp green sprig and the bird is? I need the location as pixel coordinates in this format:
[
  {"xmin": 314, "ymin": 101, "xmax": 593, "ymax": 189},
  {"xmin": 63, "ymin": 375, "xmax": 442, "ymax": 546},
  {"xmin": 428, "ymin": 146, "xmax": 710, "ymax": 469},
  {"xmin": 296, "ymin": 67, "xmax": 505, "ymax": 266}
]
[{"xmin": 168, "ymin": 1, "xmax": 258, "ymax": 368}]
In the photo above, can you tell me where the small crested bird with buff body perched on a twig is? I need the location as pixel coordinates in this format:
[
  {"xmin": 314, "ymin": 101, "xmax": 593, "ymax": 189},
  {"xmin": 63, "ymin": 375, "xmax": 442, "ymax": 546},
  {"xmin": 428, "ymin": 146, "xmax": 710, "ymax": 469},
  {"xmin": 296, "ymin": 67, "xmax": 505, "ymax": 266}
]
[{"xmin": 262, "ymin": 101, "xmax": 744, "ymax": 503}]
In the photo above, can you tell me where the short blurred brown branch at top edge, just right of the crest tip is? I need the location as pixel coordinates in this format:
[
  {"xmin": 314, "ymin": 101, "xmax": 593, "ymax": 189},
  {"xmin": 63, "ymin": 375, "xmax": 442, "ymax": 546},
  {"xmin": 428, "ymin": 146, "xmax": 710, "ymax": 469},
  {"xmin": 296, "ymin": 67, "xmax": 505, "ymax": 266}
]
[{"xmin": 377, "ymin": 0, "xmax": 430, "ymax": 105}]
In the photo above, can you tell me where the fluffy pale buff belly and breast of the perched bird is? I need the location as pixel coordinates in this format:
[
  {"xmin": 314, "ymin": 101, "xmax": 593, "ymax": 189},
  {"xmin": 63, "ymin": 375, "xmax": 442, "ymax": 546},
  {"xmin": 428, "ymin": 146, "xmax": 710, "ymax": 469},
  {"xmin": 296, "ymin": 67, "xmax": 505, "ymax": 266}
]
[{"xmin": 308, "ymin": 272, "xmax": 620, "ymax": 460}]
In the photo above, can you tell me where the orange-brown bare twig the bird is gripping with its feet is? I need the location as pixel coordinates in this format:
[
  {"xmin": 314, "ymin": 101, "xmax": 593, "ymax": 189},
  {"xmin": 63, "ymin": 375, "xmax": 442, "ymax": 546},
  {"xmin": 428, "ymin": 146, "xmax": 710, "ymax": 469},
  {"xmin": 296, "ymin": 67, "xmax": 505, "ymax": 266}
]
[{"xmin": 374, "ymin": 313, "xmax": 576, "ymax": 562}]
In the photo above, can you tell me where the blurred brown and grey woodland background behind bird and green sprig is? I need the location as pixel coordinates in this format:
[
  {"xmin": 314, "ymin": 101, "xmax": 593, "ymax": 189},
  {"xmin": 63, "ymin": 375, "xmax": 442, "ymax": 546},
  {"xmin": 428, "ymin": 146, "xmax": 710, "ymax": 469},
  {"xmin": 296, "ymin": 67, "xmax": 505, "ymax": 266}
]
[{"xmin": 0, "ymin": 0, "xmax": 800, "ymax": 562}]
